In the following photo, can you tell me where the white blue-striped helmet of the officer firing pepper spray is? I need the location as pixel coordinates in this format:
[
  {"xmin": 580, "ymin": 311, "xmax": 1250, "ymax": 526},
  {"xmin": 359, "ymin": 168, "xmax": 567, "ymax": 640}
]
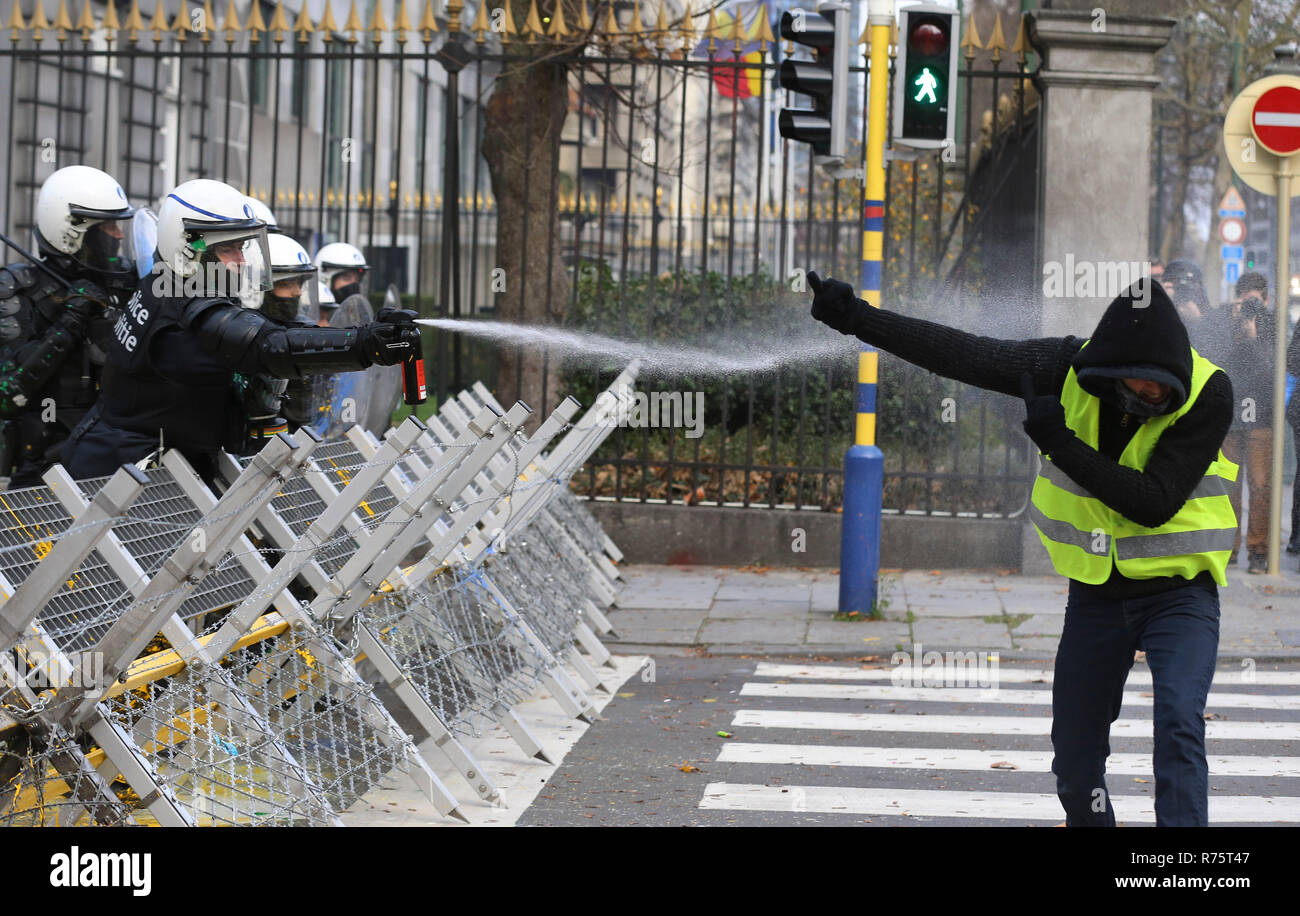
[{"xmin": 157, "ymin": 178, "xmax": 270, "ymax": 298}]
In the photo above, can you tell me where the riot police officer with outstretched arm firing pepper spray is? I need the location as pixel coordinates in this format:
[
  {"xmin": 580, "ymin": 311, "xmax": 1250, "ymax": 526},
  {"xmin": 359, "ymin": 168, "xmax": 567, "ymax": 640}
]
[{"xmin": 68, "ymin": 179, "xmax": 420, "ymax": 479}]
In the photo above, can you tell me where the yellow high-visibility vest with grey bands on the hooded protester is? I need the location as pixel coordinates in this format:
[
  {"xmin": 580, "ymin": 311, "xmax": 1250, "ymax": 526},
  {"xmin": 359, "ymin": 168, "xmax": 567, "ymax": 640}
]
[{"xmin": 1030, "ymin": 343, "xmax": 1238, "ymax": 585}]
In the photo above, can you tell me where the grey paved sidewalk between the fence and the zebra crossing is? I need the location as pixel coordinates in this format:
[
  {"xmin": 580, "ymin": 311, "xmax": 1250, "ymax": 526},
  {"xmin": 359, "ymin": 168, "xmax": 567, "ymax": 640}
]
[{"xmin": 606, "ymin": 553, "xmax": 1300, "ymax": 661}]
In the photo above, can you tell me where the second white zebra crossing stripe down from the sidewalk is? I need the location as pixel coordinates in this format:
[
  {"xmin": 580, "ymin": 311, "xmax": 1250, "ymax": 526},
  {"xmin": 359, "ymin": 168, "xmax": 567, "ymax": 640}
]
[{"xmin": 740, "ymin": 682, "xmax": 1300, "ymax": 709}]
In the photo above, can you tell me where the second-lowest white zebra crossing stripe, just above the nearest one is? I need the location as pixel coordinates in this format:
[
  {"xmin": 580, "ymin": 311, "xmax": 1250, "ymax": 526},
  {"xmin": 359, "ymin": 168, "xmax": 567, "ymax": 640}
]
[{"xmin": 718, "ymin": 742, "xmax": 1300, "ymax": 778}]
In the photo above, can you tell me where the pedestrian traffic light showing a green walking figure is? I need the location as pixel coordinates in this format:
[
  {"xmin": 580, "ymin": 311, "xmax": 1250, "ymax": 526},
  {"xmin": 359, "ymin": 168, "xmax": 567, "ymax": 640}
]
[{"xmin": 893, "ymin": 4, "xmax": 957, "ymax": 149}]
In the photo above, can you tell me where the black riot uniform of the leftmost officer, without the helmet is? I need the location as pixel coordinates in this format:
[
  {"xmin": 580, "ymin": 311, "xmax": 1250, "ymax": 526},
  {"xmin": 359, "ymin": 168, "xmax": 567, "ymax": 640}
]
[{"xmin": 0, "ymin": 264, "xmax": 113, "ymax": 490}]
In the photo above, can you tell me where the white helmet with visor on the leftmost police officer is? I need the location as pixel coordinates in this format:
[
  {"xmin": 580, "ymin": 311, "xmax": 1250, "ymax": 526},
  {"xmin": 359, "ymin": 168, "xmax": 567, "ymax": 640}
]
[{"xmin": 36, "ymin": 165, "xmax": 137, "ymax": 288}]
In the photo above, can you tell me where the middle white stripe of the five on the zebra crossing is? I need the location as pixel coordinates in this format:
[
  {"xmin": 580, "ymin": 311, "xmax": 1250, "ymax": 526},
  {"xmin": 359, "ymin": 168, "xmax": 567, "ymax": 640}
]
[{"xmin": 732, "ymin": 709, "xmax": 1300, "ymax": 741}]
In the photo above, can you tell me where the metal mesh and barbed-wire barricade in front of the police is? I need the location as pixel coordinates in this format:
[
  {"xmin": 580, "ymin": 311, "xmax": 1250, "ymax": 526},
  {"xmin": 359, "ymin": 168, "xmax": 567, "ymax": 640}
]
[{"xmin": 0, "ymin": 364, "xmax": 637, "ymax": 825}]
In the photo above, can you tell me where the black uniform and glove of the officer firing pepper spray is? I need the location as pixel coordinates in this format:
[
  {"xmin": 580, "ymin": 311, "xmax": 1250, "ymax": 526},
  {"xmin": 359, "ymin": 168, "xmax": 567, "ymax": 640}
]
[{"xmin": 68, "ymin": 275, "xmax": 420, "ymax": 481}]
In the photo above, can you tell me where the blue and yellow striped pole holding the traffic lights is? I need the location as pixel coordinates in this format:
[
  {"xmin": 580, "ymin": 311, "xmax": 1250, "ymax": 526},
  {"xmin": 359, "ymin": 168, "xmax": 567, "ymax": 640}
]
[{"xmin": 840, "ymin": 0, "xmax": 893, "ymax": 615}]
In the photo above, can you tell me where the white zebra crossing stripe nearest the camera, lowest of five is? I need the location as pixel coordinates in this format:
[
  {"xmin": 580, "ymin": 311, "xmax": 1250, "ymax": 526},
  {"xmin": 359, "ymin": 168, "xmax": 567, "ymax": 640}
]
[{"xmin": 699, "ymin": 782, "xmax": 1300, "ymax": 824}]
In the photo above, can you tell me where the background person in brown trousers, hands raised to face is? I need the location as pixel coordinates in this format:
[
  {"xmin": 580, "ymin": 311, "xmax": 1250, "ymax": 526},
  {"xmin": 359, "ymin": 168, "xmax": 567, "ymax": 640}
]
[{"xmin": 1223, "ymin": 270, "xmax": 1277, "ymax": 573}]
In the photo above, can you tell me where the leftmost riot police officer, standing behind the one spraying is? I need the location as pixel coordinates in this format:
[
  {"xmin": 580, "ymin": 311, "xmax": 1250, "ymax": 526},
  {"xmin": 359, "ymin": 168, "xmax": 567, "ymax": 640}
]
[{"xmin": 0, "ymin": 165, "xmax": 137, "ymax": 489}]
